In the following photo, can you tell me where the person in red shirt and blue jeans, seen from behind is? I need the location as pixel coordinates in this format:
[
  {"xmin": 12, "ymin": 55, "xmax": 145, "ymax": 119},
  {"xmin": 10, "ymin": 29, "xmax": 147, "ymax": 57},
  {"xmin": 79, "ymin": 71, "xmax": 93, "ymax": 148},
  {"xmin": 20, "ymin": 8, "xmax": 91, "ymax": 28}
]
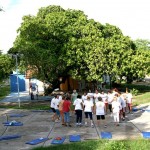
[{"xmin": 63, "ymin": 97, "xmax": 71, "ymax": 127}]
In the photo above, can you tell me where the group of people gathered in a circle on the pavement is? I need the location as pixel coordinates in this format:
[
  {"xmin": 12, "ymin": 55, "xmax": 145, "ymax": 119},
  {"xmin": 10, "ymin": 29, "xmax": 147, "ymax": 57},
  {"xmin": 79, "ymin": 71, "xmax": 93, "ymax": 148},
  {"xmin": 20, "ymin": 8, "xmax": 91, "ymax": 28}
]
[{"xmin": 50, "ymin": 89, "xmax": 132, "ymax": 128}]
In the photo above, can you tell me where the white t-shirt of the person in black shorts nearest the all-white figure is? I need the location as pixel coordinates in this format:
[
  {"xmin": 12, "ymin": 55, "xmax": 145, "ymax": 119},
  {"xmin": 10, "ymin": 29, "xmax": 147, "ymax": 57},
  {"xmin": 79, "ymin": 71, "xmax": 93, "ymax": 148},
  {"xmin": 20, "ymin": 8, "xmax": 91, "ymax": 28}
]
[{"xmin": 96, "ymin": 101, "xmax": 105, "ymax": 115}]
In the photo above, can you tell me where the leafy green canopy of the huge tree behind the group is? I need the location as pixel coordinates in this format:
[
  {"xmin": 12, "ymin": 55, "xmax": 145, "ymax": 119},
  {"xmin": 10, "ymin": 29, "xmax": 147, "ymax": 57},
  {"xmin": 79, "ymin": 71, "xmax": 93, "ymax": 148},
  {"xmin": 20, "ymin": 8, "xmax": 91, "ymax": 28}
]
[{"xmin": 11, "ymin": 5, "xmax": 147, "ymax": 86}]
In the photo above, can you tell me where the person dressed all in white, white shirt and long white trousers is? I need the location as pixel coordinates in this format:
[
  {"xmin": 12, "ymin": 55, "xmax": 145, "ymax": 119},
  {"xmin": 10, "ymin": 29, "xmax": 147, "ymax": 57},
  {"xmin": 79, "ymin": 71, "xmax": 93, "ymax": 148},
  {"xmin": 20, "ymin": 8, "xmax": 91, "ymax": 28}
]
[{"xmin": 112, "ymin": 96, "xmax": 121, "ymax": 126}]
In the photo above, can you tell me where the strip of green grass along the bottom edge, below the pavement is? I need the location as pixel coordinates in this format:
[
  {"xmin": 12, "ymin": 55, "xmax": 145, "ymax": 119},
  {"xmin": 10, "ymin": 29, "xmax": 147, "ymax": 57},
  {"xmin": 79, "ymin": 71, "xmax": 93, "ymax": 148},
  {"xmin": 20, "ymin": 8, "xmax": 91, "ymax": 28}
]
[{"xmin": 32, "ymin": 139, "xmax": 150, "ymax": 150}]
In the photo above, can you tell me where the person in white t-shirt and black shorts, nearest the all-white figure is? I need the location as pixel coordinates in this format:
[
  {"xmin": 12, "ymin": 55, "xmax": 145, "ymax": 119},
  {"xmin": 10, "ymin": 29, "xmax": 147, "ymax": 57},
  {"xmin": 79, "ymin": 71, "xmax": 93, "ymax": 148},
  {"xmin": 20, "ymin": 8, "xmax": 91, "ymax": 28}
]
[{"xmin": 95, "ymin": 97, "xmax": 107, "ymax": 128}]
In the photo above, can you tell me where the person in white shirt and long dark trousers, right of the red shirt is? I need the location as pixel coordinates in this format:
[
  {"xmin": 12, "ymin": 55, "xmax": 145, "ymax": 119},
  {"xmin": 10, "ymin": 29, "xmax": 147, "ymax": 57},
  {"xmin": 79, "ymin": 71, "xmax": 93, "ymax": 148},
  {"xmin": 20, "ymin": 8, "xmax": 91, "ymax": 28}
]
[{"xmin": 73, "ymin": 95, "xmax": 83, "ymax": 126}]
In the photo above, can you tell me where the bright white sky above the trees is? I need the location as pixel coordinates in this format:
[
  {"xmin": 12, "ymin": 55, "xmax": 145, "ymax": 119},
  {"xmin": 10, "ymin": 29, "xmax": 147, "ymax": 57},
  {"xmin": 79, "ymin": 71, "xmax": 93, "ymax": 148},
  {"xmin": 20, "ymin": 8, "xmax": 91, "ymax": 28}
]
[{"xmin": 0, "ymin": 0, "xmax": 150, "ymax": 53}]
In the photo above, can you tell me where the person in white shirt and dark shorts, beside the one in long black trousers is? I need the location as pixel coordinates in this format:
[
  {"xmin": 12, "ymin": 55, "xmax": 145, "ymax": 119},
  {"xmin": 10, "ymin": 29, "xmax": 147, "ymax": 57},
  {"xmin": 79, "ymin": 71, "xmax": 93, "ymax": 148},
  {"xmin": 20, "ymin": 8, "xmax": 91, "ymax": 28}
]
[{"xmin": 83, "ymin": 97, "xmax": 94, "ymax": 127}]
